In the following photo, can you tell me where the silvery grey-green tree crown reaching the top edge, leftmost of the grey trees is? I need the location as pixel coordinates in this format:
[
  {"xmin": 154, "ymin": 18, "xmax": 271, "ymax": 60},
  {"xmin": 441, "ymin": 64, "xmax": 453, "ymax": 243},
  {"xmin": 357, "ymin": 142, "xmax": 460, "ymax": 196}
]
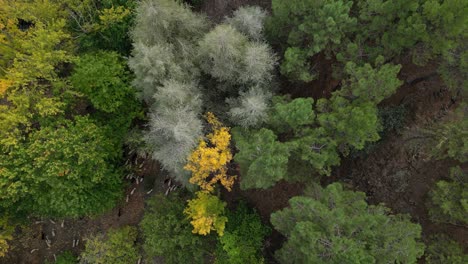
[{"xmin": 128, "ymin": 0, "xmax": 209, "ymax": 104}]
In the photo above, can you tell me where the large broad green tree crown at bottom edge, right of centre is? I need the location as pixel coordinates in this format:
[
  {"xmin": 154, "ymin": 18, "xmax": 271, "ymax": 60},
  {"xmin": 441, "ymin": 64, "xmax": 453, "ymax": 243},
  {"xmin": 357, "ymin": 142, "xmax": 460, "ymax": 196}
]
[{"xmin": 271, "ymin": 183, "xmax": 424, "ymax": 263}]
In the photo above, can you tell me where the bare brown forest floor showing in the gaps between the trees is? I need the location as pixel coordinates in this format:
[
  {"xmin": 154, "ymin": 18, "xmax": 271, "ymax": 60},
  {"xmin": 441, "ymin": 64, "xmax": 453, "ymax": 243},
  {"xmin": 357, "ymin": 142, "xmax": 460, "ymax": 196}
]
[{"xmin": 0, "ymin": 0, "xmax": 468, "ymax": 264}]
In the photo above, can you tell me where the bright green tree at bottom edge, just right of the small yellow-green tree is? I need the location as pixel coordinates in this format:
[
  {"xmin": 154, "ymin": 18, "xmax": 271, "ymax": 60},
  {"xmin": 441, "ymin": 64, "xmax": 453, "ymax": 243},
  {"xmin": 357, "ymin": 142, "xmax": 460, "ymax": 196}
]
[{"xmin": 215, "ymin": 202, "xmax": 270, "ymax": 264}]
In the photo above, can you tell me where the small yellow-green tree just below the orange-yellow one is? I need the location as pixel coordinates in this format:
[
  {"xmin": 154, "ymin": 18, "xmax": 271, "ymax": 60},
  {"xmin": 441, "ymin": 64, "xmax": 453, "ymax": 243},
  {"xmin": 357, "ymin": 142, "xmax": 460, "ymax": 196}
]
[{"xmin": 184, "ymin": 191, "xmax": 228, "ymax": 236}]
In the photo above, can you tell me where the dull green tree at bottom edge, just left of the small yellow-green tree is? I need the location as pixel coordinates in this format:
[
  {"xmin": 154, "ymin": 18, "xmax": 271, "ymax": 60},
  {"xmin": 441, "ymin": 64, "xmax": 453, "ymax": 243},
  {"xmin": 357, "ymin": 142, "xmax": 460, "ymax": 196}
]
[{"xmin": 140, "ymin": 195, "xmax": 207, "ymax": 264}]
